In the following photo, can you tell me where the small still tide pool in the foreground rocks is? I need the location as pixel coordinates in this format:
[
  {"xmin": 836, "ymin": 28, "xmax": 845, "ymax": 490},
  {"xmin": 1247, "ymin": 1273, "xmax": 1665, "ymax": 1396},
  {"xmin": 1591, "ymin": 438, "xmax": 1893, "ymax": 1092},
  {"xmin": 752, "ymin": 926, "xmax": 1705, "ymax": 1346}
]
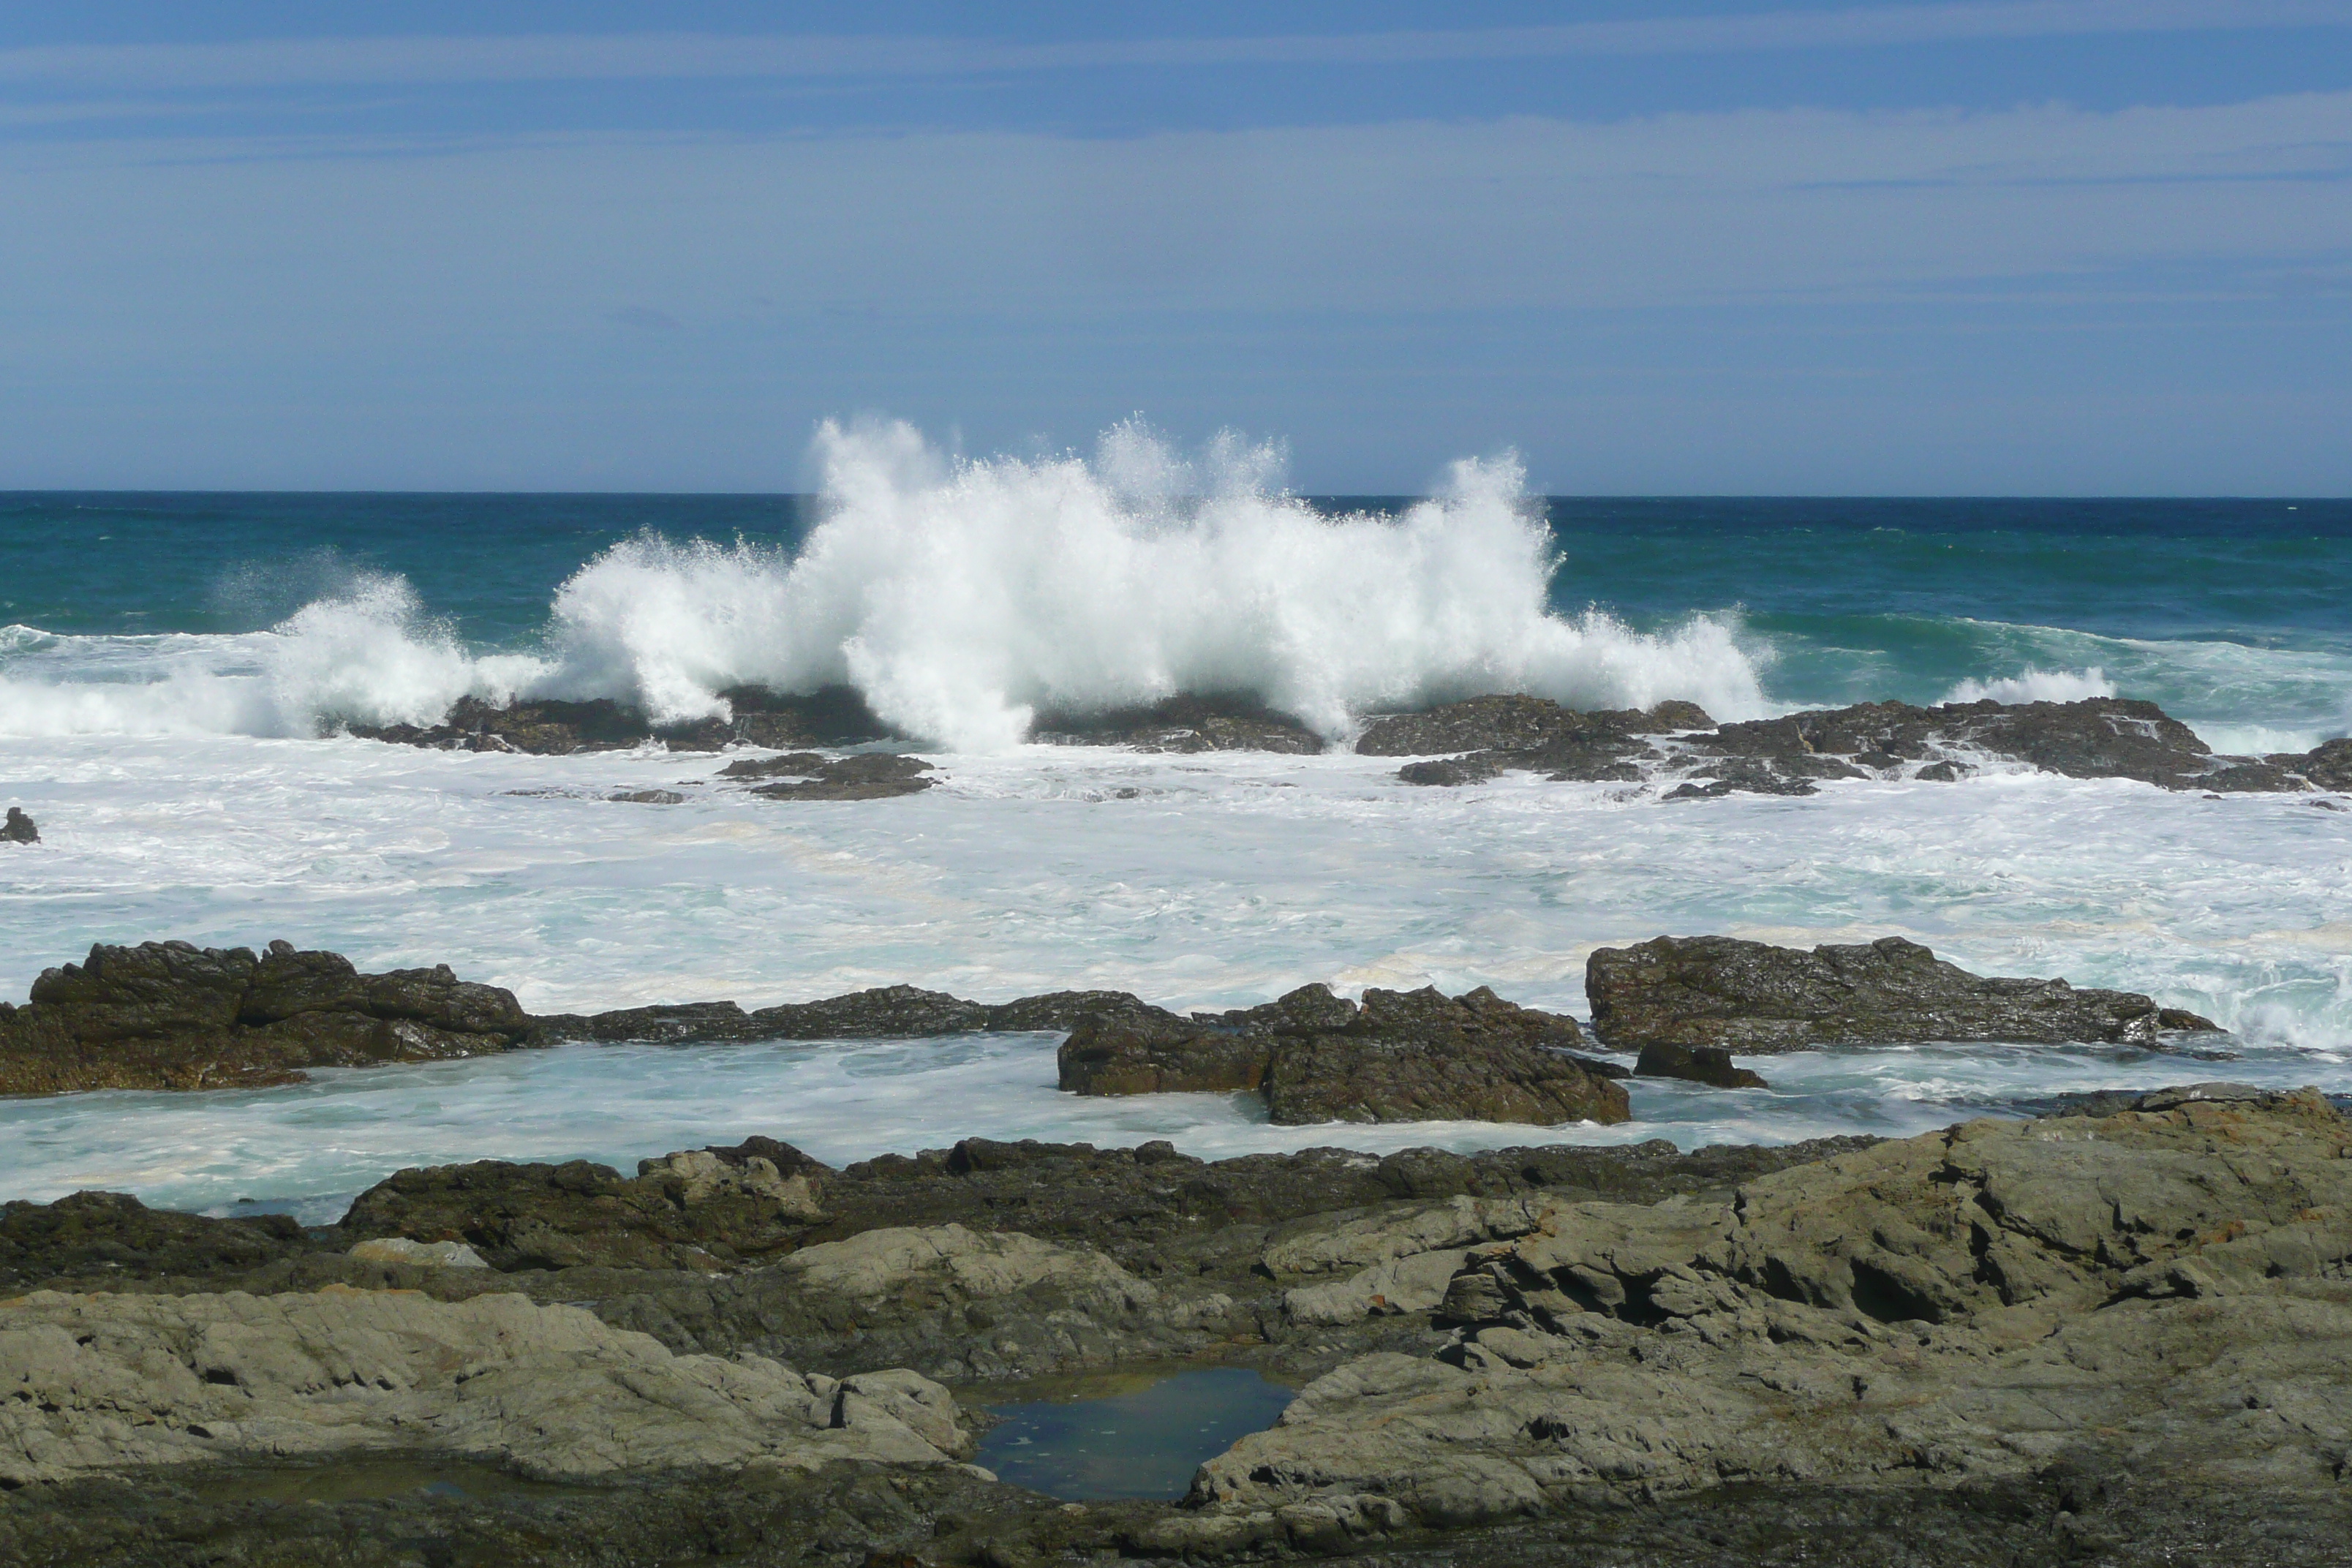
[{"xmin": 979, "ymin": 1366, "xmax": 1292, "ymax": 1500}]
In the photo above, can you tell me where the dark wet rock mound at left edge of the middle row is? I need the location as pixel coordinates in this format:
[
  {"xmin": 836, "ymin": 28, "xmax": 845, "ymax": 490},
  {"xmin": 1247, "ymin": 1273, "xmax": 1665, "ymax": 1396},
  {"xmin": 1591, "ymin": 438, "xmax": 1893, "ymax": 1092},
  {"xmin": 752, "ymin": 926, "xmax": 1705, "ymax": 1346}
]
[{"xmin": 0, "ymin": 943, "xmax": 532, "ymax": 1096}]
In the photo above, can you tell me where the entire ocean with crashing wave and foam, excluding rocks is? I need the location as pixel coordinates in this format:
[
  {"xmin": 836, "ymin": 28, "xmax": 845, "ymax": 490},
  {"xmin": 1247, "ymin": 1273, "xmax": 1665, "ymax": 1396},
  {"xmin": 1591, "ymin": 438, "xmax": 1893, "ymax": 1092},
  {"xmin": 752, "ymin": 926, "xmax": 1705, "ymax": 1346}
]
[{"xmin": 0, "ymin": 428, "xmax": 2352, "ymax": 1218}]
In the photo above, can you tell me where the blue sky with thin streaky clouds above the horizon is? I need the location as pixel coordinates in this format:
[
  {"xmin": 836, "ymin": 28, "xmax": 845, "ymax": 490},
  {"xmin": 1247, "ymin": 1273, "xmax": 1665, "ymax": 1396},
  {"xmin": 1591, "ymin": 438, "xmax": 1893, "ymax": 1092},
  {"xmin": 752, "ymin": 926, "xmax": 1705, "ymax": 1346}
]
[{"xmin": 0, "ymin": 0, "xmax": 2352, "ymax": 496}]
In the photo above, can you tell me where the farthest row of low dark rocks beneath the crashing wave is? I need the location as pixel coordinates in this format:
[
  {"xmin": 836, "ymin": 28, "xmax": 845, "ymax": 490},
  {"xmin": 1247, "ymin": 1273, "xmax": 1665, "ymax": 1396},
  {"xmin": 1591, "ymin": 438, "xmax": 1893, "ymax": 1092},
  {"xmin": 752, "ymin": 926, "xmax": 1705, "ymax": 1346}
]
[{"xmin": 317, "ymin": 687, "xmax": 2352, "ymax": 802}]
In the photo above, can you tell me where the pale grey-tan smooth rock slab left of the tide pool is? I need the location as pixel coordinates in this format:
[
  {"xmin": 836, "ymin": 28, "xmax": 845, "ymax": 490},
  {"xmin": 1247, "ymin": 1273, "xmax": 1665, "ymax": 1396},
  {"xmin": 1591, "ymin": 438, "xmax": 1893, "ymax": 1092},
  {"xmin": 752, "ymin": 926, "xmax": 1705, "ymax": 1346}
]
[{"xmin": 0, "ymin": 1291, "xmax": 969, "ymax": 1488}]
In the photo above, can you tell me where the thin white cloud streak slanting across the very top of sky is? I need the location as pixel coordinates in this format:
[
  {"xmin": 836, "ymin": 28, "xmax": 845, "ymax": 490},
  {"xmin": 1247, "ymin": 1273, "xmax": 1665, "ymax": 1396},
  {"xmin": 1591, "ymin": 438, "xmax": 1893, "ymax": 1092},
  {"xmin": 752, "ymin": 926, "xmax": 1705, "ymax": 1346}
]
[{"xmin": 0, "ymin": 0, "xmax": 2352, "ymax": 91}]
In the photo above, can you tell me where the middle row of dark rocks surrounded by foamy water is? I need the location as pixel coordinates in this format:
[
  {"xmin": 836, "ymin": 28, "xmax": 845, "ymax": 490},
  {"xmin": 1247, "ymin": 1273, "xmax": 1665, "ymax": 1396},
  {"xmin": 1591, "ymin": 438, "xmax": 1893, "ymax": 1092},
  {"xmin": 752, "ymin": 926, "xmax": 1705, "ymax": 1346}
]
[{"xmin": 0, "ymin": 935, "xmax": 2218, "ymax": 1104}]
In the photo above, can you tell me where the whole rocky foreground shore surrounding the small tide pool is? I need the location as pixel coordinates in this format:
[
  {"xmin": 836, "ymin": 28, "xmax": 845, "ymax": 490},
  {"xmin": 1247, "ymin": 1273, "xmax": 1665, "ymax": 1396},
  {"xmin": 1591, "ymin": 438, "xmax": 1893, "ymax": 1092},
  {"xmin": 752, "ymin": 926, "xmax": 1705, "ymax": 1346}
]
[{"xmin": 0, "ymin": 1084, "xmax": 2352, "ymax": 1568}]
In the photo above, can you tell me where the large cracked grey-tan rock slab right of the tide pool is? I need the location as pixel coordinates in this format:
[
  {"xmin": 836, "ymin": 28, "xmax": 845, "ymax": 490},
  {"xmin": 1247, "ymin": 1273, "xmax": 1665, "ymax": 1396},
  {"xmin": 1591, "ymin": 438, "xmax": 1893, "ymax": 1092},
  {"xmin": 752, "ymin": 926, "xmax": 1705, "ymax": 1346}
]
[{"xmin": 1176, "ymin": 1090, "xmax": 2352, "ymax": 1561}]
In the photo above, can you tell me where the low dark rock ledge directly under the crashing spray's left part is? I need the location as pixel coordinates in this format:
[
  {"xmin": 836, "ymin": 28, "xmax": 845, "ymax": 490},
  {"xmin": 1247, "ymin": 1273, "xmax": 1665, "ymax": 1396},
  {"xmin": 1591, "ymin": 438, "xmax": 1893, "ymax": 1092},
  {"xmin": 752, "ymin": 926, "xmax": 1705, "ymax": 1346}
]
[{"xmin": 344, "ymin": 687, "xmax": 899, "ymax": 757}]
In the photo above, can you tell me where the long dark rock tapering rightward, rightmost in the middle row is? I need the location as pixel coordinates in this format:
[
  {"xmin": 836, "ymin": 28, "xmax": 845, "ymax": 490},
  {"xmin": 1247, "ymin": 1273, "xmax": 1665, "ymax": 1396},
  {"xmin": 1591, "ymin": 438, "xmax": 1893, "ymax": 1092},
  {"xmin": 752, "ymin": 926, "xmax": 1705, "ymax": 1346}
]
[{"xmin": 1586, "ymin": 935, "xmax": 2215, "ymax": 1053}]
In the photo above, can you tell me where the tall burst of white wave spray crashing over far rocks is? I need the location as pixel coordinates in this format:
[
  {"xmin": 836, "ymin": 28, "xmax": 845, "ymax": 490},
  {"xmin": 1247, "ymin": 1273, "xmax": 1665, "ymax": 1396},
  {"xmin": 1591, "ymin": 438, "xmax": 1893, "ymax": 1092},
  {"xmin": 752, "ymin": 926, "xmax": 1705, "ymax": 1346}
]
[{"xmin": 0, "ymin": 421, "xmax": 1766, "ymax": 750}]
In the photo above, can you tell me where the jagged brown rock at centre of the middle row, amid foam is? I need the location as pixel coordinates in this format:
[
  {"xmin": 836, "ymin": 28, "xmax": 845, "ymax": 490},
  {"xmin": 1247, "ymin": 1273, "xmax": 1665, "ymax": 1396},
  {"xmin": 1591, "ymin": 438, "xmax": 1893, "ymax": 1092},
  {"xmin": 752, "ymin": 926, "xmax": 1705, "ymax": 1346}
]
[{"xmin": 1058, "ymin": 985, "xmax": 1632, "ymax": 1126}]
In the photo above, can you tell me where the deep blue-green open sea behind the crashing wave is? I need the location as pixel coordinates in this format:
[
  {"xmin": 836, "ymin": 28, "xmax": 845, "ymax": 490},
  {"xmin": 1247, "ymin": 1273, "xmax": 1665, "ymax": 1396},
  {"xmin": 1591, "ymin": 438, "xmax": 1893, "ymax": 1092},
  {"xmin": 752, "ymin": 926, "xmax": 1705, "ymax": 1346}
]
[{"xmin": 0, "ymin": 494, "xmax": 2352, "ymax": 728}]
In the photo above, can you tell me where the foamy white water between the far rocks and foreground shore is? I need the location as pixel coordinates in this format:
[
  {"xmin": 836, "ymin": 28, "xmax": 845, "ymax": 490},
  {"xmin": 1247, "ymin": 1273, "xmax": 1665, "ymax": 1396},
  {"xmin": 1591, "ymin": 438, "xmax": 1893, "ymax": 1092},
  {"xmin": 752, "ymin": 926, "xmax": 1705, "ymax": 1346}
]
[{"xmin": 0, "ymin": 736, "xmax": 2352, "ymax": 1213}]
